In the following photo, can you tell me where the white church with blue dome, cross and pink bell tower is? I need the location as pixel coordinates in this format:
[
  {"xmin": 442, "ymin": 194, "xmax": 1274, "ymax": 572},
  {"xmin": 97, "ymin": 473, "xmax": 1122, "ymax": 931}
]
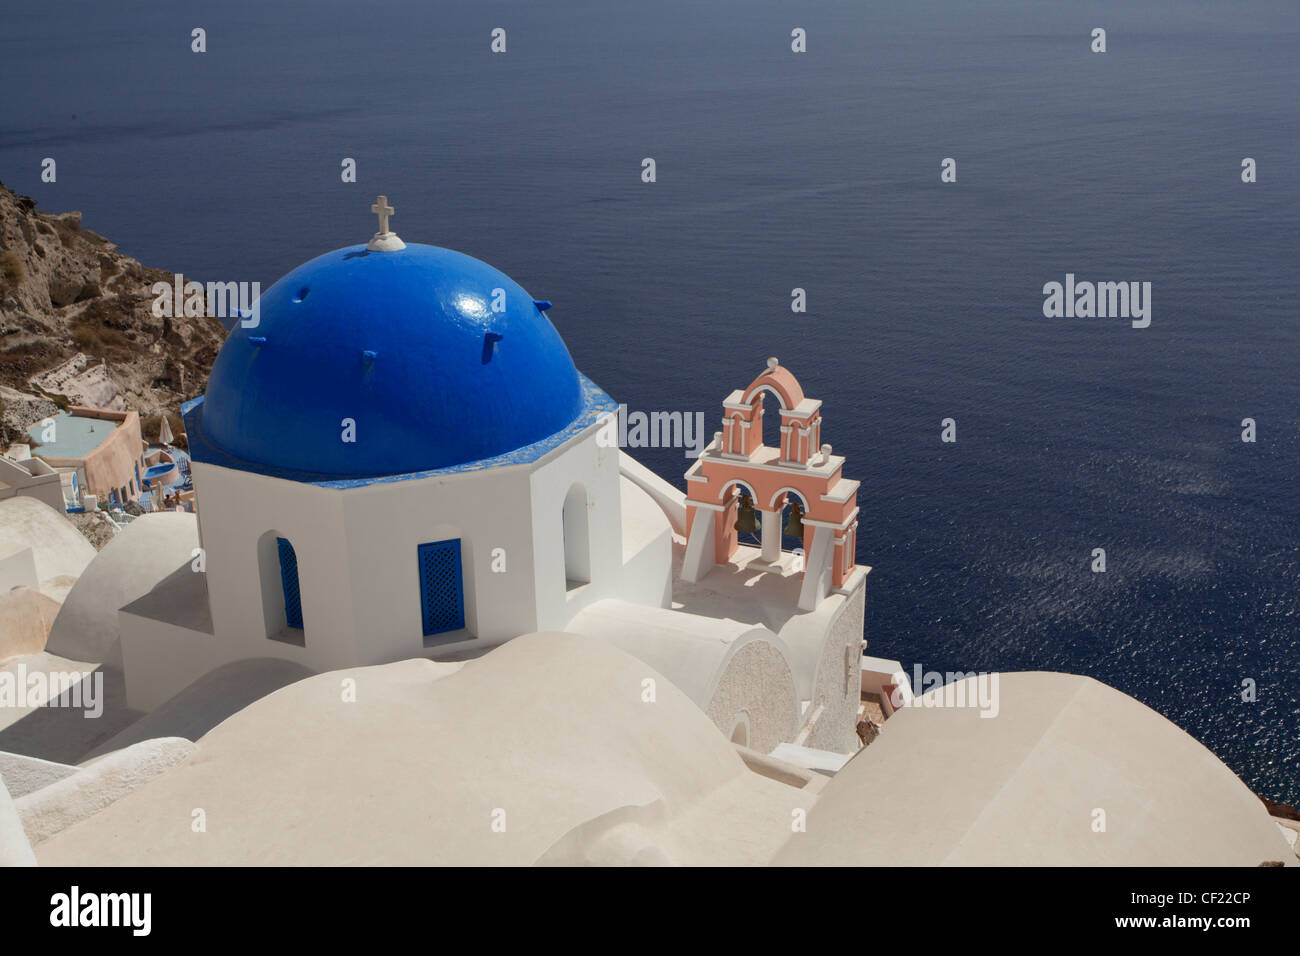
[{"xmin": 101, "ymin": 196, "xmax": 878, "ymax": 753}]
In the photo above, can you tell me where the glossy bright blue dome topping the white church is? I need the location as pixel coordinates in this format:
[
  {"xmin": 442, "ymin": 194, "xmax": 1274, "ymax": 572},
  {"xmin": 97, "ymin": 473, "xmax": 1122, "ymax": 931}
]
[{"xmin": 202, "ymin": 243, "xmax": 584, "ymax": 479}]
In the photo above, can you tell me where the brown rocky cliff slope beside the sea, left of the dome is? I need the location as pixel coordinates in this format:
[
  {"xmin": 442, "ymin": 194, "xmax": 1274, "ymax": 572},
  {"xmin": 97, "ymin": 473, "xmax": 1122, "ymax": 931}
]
[{"xmin": 0, "ymin": 183, "xmax": 225, "ymax": 446}]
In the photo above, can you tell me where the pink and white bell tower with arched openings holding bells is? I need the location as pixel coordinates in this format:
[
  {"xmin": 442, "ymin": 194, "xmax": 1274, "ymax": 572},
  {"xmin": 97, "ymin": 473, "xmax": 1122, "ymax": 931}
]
[{"xmin": 681, "ymin": 358, "xmax": 867, "ymax": 610}]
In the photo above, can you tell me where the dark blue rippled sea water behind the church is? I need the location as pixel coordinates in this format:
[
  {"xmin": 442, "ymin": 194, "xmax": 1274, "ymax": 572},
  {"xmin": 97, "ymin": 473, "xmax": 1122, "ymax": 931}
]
[{"xmin": 0, "ymin": 0, "xmax": 1300, "ymax": 803}]
